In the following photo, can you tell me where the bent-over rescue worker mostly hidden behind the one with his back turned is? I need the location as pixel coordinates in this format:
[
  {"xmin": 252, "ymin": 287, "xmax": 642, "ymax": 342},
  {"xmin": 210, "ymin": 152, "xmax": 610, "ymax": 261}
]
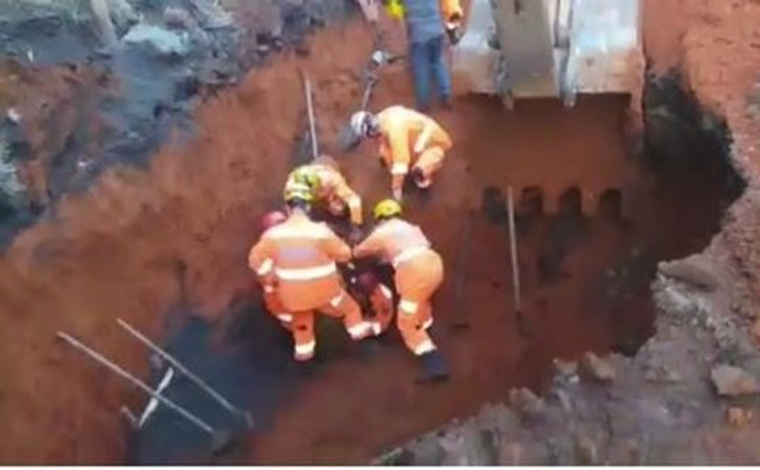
[{"xmin": 285, "ymin": 155, "xmax": 363, "ymax": 225}]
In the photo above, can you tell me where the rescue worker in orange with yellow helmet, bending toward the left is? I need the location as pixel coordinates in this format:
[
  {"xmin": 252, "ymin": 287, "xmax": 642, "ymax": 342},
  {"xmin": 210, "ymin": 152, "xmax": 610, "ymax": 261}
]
[{"xmin": 354, "ymin": 199, "xmax": 448, "ymax": 380}]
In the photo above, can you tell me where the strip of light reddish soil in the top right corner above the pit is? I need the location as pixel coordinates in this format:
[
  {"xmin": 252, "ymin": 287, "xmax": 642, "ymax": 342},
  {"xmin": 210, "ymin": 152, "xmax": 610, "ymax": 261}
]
[{"xmin": 644, "ymin": 0, "xmax": 760, "ymax": 302}]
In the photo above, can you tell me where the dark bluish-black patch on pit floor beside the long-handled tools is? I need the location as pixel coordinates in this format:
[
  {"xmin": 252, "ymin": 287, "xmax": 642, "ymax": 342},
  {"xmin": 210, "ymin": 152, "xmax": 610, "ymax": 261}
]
[{"xmin": 127, "ymin": 301, "xmax": 298, "ymax": 465}]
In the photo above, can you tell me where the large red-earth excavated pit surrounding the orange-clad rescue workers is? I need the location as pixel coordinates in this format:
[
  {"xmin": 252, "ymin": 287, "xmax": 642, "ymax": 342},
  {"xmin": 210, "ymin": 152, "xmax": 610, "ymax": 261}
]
[{"xmin": 0, "ymin": 21, "xmax": 737, "ymax": 463}]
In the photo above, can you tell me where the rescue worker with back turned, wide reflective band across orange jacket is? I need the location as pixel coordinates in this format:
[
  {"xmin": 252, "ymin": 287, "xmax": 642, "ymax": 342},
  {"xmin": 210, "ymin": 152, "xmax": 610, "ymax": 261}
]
[{"xmin": 248, "ymin": 182, "xmax": 372, "ymax": 362}]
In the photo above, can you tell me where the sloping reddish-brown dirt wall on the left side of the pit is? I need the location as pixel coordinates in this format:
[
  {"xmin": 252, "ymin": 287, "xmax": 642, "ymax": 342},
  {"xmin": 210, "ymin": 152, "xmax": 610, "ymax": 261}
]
[{"xmin": 0, "ymin": 24, "xmax": 380, "ymax": 463}]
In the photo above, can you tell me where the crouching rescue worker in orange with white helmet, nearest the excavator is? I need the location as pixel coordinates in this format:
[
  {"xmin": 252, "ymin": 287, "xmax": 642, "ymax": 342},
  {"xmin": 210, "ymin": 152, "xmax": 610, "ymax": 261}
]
[{"xmin": 351, "ymin": 106, "xmax": 452, "ymax": 201}]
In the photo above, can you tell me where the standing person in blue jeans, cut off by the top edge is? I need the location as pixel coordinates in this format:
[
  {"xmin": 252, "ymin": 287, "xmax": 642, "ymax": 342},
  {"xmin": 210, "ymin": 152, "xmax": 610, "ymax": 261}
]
[{"xmin": 387, "ymin": 0, "xmax": 462, "ymax": 111}]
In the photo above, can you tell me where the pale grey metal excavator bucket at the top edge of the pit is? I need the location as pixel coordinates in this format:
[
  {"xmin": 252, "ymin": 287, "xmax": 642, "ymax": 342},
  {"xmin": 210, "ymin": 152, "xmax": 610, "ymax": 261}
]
[{"xmin": 452, "ymin": 0, "xmax": 643, "ymax": 105}]
